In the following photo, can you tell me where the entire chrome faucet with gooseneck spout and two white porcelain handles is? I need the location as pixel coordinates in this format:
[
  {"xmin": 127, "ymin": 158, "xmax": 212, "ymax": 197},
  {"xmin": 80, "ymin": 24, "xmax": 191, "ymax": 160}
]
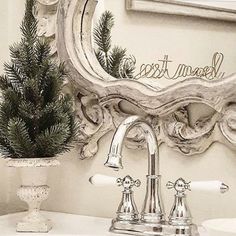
[{"xmin": 89, "ymin": 116, "xmax": 229, "ymax": 236}]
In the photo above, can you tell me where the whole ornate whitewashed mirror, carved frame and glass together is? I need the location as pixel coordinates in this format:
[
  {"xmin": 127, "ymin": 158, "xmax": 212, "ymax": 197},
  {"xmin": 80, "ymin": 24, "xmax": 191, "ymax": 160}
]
[{"xmin": 38, "ymin": 0, "xmax": 236, "ymax": 158}]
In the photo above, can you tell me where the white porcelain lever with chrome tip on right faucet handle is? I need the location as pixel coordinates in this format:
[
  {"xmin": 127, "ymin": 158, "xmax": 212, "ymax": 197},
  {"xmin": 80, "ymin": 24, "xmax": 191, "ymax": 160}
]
[{"xmin": 189, "ymin": 180, "xmax": 229, "ymax": 193}]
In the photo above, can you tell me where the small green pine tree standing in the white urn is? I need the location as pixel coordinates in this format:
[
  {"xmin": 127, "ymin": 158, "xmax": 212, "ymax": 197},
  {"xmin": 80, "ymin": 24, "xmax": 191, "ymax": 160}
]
[{"xmin": 0, "ymin": 0, "xmax": 78, "ymax": 158}]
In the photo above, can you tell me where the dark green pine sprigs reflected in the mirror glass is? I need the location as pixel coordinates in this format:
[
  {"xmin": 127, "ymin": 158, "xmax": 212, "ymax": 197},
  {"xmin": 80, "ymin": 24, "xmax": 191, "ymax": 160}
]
[{"xmin": 94, "ymin": 11, "xmax": 135, "ymax": 79}]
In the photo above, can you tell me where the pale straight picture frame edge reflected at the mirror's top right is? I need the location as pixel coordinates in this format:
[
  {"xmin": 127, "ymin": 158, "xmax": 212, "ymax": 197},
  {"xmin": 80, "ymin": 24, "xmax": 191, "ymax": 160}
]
[{"xmin": 126, "ymin": 0, "xmax": 236, "ymax": 22}]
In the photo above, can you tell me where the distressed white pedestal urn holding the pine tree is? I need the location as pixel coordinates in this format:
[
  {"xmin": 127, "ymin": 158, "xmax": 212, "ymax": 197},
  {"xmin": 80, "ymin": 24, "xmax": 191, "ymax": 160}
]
[{"xmin": 7, "ymin": 158, "xmax": 60, "ymax": 232}]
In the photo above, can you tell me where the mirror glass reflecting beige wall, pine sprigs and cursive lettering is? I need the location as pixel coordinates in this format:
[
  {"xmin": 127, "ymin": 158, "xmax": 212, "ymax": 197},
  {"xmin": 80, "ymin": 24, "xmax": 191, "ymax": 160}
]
[{"xmin": 92, "ymin": 0, "xmax": 236, "ymax": 89}]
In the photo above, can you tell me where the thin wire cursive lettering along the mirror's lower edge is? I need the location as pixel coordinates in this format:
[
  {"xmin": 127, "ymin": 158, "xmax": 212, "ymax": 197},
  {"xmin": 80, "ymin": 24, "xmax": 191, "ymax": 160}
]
[{"xmin": 133, "ymin": 52, "xmax": 225, "ymax": 80}]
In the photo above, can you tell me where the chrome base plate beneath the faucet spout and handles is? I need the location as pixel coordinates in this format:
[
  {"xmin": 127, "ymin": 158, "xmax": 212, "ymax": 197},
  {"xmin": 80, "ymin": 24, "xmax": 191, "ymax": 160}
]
[{"xmin": 110, "ymin": 219, "xmax": 199, "ymax": 236}]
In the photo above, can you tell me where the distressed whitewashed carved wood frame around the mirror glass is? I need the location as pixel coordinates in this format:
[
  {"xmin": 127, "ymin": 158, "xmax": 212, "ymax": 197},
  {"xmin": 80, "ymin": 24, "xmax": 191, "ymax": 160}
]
[{"xmin": 38, "ymin": 0, "xmax": 236, "ymax": 158}]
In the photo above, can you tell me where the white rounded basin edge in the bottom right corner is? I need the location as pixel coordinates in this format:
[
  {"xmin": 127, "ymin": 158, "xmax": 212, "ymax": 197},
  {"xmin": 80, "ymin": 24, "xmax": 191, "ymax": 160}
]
[{"xmin": 202, "ymin": 218, "xmax": 236, "ymax": 236}]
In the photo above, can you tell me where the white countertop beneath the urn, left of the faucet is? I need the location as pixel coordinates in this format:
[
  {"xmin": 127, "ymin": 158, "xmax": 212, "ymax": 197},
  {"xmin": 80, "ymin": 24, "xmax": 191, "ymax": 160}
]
[{"xmin": 0, "ymin": 211, "xmax": 207, "ymax": 236}]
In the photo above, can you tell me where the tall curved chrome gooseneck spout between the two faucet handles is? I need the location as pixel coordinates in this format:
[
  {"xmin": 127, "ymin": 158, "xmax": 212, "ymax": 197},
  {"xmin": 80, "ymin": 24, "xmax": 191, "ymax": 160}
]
[{"xmin": 104, "ymin": 116, "xmax": 164, "ymax": 223}]
